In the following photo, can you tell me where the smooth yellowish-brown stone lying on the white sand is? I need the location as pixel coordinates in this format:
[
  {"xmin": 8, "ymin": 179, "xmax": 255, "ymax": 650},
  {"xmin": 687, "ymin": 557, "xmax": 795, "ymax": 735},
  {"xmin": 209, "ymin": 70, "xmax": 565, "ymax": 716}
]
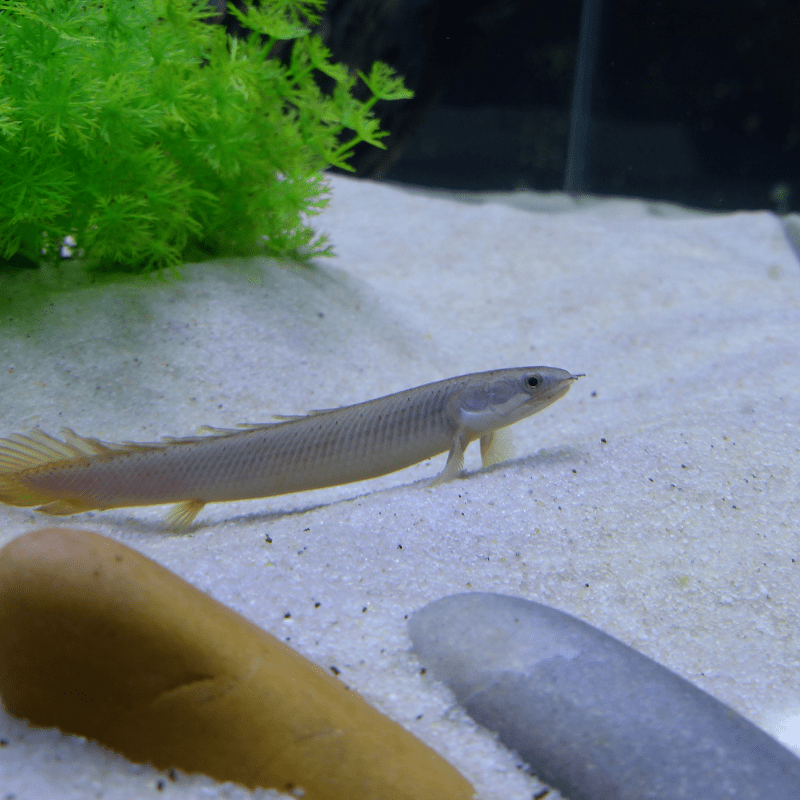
[{"xmin": 0, "ymin": 528, "xmax": 473, "ymax": 800}]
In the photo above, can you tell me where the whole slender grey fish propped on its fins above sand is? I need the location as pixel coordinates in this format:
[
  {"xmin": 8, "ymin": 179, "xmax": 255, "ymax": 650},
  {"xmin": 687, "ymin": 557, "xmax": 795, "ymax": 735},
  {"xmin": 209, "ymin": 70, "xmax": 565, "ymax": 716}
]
[{"xmin": 0, "ymin": 367, "xmax": 580, "ymax": 528}]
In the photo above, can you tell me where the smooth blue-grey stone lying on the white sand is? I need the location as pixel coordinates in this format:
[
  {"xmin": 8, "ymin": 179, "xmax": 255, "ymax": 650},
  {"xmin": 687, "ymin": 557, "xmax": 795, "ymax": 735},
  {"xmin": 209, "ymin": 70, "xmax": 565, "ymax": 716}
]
[{"xmin": 409, "ymin": 593, "xmax": 800, "ymax": 800}]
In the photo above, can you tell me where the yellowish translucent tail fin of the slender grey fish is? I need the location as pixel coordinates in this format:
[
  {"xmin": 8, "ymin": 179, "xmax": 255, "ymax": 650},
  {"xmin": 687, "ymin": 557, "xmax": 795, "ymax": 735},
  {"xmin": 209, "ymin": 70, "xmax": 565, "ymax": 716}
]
[{"xmin": 0, "ymin": 428, "xmax": 118, "ymax": 515}]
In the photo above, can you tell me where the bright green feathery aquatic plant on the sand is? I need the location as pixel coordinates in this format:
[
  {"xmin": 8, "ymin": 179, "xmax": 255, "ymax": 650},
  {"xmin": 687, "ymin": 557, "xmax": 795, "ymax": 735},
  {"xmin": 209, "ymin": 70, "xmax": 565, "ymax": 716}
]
[{"xmin": 0, "ymin": 0, "xmax": 410, "ymax": 272}]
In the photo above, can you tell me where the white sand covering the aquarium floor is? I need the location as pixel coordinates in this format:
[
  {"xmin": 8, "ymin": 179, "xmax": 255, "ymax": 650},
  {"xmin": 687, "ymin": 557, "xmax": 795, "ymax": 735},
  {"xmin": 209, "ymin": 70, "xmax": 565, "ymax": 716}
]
[{"xmin": 0, "ymin": 177, "xmax": 800, "ymax": 800}]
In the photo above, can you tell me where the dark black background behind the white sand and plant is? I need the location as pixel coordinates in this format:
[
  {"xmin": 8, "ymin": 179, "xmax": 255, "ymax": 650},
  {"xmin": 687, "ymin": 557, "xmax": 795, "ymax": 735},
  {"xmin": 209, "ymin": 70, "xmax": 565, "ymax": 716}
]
[{"xmin": 220, "ymin": 0, "xmax": 800, "ymax": 213}]
